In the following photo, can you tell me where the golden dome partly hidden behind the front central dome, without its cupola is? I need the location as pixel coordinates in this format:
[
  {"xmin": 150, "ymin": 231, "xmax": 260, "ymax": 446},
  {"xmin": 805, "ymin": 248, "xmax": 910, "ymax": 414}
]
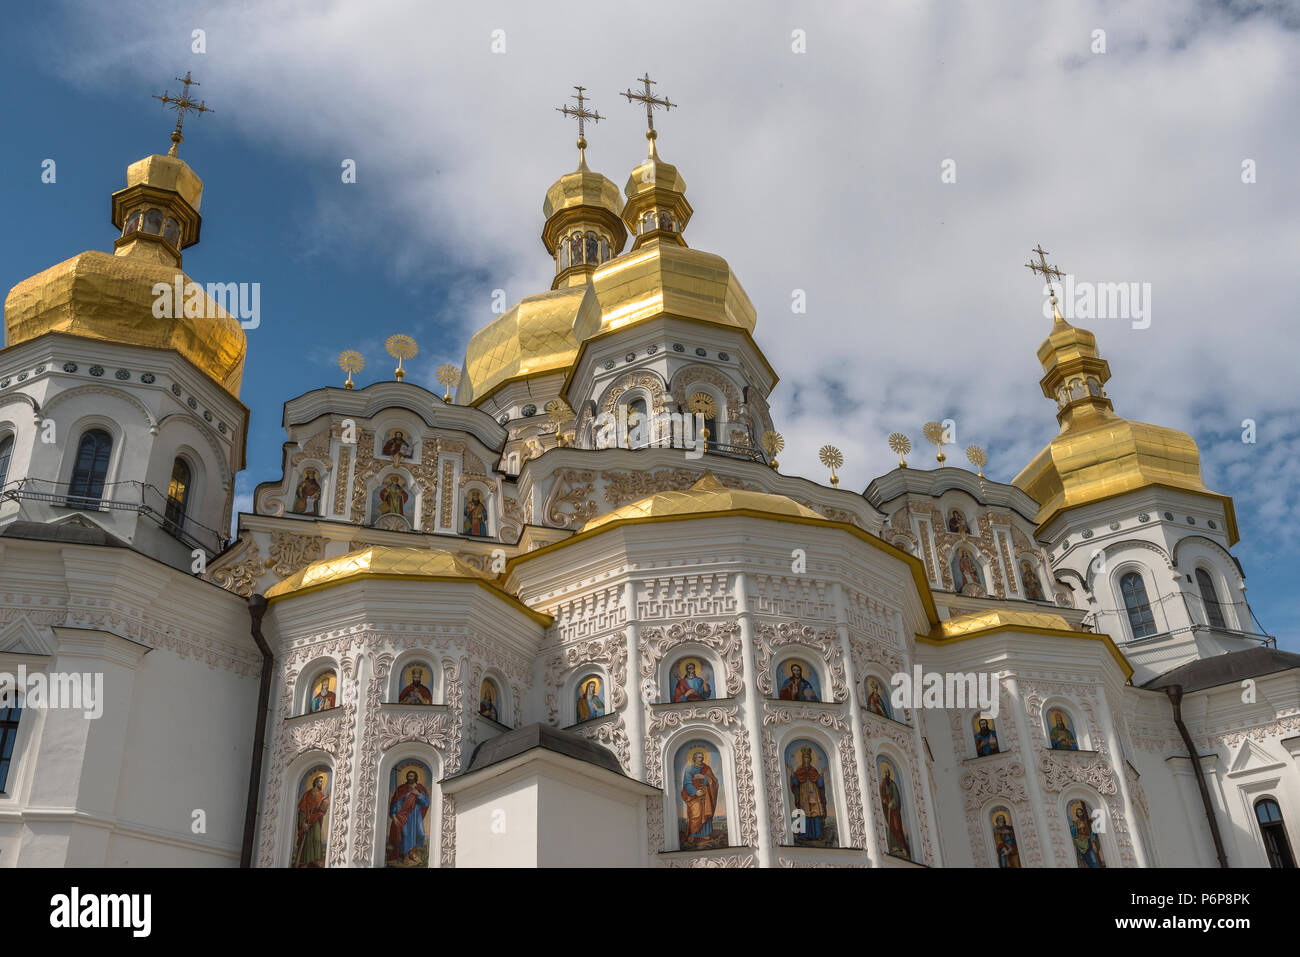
[{"xmin": 456, "ymin": 282, "xmax": 601, "ymax": 406}]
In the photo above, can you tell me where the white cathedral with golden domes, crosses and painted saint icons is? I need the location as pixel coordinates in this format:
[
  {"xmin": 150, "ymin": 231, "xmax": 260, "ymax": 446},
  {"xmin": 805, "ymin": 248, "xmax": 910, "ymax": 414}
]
[{"xmin": 0, "ymin": 78, "xmax": 1300, "ymax": 869}]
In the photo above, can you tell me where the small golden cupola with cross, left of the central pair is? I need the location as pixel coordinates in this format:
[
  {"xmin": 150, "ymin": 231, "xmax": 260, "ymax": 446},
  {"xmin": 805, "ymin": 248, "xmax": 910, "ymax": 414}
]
[{"xmin": 542, "ymin": 86, "xmax": 628, "ymax": 289}]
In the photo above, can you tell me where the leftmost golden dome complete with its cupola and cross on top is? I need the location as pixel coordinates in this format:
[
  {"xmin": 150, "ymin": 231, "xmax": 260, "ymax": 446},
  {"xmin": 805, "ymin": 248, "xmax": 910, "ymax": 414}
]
[{"xmin": 4, "ymin": 73, "xmax": 248, "ymax": 398}]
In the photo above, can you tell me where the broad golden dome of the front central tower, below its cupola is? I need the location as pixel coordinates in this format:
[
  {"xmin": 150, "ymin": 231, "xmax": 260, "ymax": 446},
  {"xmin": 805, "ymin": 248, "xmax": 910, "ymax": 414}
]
[{"xmin": 593, "ymin": 237, "xmax": 758, "ymax": 333}]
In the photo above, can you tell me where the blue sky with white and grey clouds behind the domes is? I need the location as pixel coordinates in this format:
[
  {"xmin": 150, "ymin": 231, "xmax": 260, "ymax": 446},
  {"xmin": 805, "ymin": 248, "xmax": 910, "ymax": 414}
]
[{"xmin": 0, "ymin": 0, "xmax": 1300, "ymax": 650}]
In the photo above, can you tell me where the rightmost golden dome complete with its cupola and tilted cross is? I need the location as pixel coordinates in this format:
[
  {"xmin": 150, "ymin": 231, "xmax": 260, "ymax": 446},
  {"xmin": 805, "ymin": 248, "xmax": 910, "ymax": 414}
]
[{"xmin": 1011, "ymin": 248, "xmax": 1236, "ymax": 542}]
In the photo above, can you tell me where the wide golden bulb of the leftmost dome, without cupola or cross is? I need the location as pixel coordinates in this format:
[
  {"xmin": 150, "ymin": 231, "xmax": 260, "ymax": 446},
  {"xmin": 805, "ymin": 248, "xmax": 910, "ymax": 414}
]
[{"xmin": 4, "ymin": 250, "xmax": 247, "ymax": 397}]
